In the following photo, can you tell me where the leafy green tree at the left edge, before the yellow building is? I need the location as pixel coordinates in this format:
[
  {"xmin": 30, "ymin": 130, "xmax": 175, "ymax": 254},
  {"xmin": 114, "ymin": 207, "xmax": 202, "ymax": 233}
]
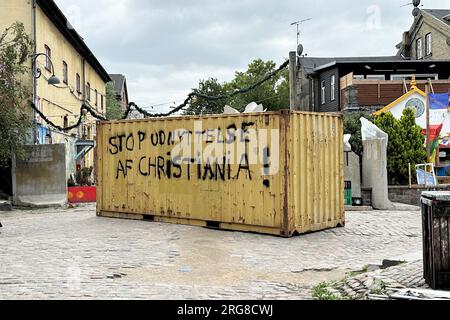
[{"xmin": 0, "ymin": 22, "xmax": 33, "ymax": 166}]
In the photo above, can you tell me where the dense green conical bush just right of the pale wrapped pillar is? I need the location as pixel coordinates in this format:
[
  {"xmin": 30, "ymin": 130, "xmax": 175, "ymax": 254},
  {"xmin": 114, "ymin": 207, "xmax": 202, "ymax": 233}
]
[{"xmin": 375, "ymin": 108, "xmax": 426, "ymax": 185}]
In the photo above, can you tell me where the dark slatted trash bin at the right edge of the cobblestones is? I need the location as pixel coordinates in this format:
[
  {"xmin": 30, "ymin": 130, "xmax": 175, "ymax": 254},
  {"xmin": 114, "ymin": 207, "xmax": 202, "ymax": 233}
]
[{"xmin": 422, "ymin": 192, "xmax": 450, "ymax": 290}]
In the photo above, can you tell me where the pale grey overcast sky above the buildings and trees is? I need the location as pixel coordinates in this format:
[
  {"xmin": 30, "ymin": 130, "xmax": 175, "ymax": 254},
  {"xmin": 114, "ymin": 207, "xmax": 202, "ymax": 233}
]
[{"xmin": 56, "ymin": 0, "xmax": 450, "ymax": 111}]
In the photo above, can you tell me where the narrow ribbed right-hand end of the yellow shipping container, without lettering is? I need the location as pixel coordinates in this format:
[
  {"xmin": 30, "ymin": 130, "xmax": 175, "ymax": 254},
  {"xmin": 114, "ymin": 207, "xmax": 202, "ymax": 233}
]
[{"xmin": 287, "ymin": 112, "xmax": 345, "ymax": 233}]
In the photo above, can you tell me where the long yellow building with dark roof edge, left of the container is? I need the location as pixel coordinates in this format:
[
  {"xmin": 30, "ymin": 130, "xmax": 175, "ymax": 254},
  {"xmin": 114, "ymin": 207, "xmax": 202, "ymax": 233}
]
[{"xmin": 0, "ymin": 0, "xmax": 111, "ymax": 179}]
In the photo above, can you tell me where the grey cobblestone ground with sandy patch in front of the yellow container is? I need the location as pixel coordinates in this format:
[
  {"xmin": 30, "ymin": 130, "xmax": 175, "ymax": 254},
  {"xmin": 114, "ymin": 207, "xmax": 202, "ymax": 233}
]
[{"xmin": 0, "ymin": 205, "xmax": 422, "ymax": 299}]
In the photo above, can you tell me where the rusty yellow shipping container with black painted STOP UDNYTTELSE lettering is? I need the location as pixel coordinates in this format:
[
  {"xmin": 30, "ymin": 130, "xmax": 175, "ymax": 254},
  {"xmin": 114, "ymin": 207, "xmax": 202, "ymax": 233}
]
[{"xmin": 97, "ymin": 111, "xmax": 345, "ymax": 237}]
